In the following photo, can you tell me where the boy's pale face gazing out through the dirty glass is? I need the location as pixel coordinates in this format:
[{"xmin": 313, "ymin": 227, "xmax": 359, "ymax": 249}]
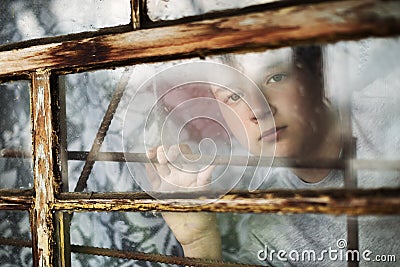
[{"xmin": 213, "ymin": 49, "xmax": 326, "ymax": 157}]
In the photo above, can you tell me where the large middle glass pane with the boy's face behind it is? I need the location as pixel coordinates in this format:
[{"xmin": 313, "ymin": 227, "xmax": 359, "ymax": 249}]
[{"xmin": 65, "ymin": 39, "xmax": 400, "ymax": 192}]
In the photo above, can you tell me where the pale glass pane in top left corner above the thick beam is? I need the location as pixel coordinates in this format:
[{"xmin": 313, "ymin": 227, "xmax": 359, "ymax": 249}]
[{"xmin": 0, "ymin": 0, "xmax": 131, "ymax": 44}]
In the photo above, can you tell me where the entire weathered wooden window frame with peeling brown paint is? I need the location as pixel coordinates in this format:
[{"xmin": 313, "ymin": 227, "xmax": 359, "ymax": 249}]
[{"xmin": 0, "ymin": 0, "xmax": 400, "ymax": 266}]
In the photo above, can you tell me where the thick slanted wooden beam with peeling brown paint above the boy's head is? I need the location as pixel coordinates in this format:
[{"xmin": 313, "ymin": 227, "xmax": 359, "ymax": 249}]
[{"xmin": 0, "ymin": 0, "xmax": 400, "ymax": 78}]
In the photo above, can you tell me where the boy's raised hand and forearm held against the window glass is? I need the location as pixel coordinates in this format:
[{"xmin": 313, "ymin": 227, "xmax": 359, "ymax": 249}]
[{"xmin": 146, "ymin": 145, "xmax": 221, "ymax": 259}]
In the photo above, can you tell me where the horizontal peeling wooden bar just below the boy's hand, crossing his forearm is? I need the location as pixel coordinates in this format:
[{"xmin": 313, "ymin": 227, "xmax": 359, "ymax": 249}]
[{"xmin": 52, "ymin": 188, "xmax": 400, "ymax": 215}]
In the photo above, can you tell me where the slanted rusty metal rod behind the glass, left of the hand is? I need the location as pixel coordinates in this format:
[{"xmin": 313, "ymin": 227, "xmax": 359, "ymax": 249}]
[{"xmin": 74, "ymin": 68, "xmax": 132, "ymax": 192}]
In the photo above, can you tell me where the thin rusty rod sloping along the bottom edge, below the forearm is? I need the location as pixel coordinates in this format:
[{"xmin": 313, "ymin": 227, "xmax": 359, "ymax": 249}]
[{"xmin": 72, "ymin": 245, "xmax": 261, "ymax": 267}]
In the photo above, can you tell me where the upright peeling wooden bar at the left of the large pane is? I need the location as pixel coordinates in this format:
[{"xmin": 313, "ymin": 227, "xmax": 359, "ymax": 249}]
[{"xmin": 31, "ymin": 70, "xmax": 58, "ymax": 267}]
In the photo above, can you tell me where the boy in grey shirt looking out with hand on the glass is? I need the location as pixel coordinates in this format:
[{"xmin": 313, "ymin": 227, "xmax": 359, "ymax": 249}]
[{"xmin": 147, "ymin": 46, "xmax": 398, "ymax": 266}]
